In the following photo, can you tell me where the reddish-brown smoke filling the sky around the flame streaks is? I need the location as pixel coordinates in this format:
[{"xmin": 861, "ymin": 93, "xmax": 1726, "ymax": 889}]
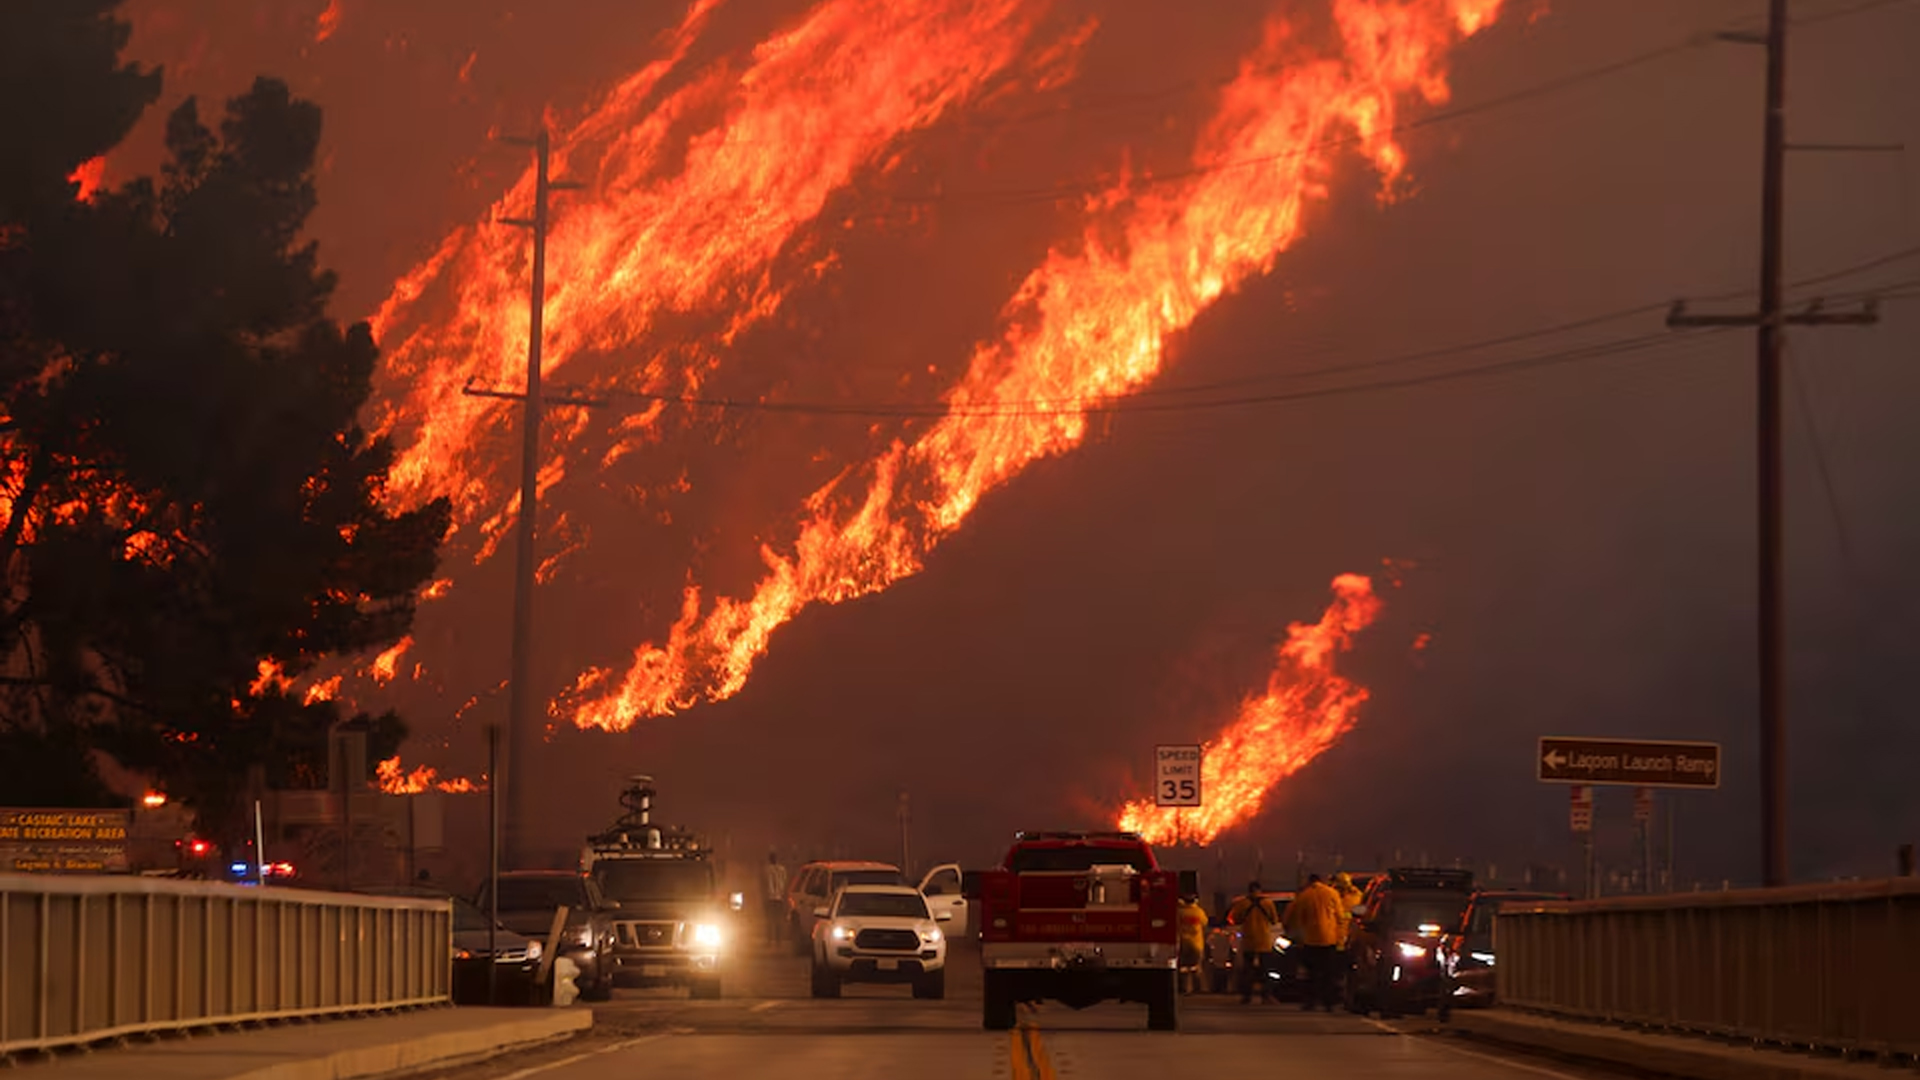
[{"xmin": 109, "ymin": 0, "xmax": 1920, "ymax": 882}]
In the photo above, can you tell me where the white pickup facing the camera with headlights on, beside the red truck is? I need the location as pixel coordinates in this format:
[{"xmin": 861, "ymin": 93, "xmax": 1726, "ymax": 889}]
[{"xmin": 814, "ymin": 886, "xmax": 952, "ymax": 999}]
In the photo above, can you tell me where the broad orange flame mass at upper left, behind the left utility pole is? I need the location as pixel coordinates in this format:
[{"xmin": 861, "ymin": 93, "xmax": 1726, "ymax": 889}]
[{"xmin": 372, "ymin": 0, "xmax": 1067, "ymax": 526}]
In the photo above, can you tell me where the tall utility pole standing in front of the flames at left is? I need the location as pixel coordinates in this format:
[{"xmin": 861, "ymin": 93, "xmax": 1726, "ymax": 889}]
[{"xmin": 465, "ymin": 127, "xmax": 591, "ymax": 865}]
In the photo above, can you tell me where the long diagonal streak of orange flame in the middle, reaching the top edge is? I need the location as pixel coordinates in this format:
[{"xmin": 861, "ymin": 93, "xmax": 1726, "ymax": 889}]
[{"xmin": 553, "ymin": 0, "xmax": 1500, "ymax": 730}]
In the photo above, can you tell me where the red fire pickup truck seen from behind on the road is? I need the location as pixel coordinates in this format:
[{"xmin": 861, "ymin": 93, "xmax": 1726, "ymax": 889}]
[{"xmin": 968, "ymin": 832, "xmax": 1190, "ymax": 1032}]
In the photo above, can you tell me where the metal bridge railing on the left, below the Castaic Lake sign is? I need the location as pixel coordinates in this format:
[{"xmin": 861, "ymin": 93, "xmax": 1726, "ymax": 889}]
[{"xmin": 0, "ymin": 874, "xmax": 453, "ymax": 1055}]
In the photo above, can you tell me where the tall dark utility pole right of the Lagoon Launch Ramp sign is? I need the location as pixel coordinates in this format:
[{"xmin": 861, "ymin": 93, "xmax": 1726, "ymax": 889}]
[{"xmin": 1667, "ymin": 0, "xmax": 1880, "ymax": 886}]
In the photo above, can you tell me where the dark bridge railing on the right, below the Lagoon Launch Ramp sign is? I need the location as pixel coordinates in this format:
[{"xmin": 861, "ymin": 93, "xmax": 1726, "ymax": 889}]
[{"xmin": 1494, "ymin": 878, "xmax": 1920, "ymax": 1055}]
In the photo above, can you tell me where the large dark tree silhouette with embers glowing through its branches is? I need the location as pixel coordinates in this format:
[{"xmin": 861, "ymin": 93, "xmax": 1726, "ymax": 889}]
[{"xmin": 0, "ymin": 0, "xmax": 449, "ymax": 830}]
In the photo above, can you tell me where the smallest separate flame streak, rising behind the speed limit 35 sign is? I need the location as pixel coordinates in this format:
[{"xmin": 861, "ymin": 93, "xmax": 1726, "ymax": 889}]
[{"xmin": 1116, "ymin": 575, "xmax": 1380, "ymax": 844}]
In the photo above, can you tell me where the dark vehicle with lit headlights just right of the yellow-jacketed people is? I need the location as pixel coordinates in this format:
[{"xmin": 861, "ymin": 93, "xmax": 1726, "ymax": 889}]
[{"xmin": 1346, "ymin": 867, "xmax": 1475, "ymax": 1019}]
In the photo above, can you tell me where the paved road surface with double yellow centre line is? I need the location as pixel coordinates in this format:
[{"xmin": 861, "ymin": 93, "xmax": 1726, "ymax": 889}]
[{"xmin": 420, "ymin": 941, "xmax": 1601, "ymax": 1080}]
